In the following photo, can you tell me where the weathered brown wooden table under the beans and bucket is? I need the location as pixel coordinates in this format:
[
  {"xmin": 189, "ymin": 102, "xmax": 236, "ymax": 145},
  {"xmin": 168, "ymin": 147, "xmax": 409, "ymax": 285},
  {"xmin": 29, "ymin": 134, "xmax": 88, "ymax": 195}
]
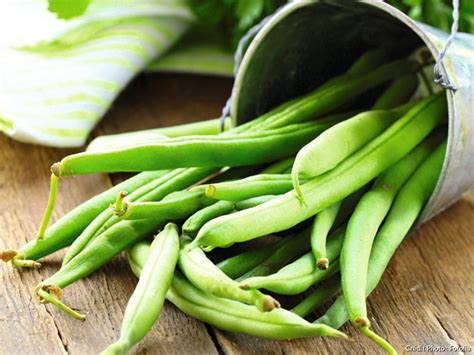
[{"xmin": 0, "ymin": 75, "xmax": 474, "ymax": 354}]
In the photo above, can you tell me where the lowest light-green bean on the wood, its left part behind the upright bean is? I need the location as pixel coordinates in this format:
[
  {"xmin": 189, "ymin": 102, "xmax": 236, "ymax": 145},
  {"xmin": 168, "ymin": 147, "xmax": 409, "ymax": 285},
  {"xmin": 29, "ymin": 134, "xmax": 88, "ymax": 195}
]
[{"xmin": 128, "ymin": 243, "xmax": 346, "ymax": 339}]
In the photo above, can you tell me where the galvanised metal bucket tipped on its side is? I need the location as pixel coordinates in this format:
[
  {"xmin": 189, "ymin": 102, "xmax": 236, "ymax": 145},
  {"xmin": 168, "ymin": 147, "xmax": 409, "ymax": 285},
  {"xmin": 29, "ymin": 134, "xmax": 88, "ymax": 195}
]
[{"xmin": 230, "ymin": 0, "xmax": 474, "ymax": 223}]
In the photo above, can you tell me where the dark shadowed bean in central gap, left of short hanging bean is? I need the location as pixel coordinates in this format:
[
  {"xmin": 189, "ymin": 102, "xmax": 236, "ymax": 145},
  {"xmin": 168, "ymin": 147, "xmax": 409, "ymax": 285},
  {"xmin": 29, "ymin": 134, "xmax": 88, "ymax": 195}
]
[{"xmin": 237, "ymin": 229, "xmax": 310, "ymax": 281}]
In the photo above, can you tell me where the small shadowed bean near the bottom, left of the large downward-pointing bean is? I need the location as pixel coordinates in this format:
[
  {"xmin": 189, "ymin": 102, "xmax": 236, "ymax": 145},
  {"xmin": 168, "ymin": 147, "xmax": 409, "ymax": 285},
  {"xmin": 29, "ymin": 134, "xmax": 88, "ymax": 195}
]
[{"xmin": 291, "ymin": 275, "xmax": 341, "ymax": 317}]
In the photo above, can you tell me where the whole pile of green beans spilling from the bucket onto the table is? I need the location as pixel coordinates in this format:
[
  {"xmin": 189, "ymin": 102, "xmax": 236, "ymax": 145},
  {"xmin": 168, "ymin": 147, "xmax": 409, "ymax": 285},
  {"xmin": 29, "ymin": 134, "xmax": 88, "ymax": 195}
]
[{"xmin": 0, "ymin": 50, "xmax": 447, "ymax": 354}]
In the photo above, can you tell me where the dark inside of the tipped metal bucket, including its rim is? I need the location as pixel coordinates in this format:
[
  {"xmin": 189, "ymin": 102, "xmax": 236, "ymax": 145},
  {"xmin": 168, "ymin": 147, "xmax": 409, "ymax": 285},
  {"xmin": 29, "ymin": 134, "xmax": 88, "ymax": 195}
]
[{"xmin": 231, "ymin": 0, "xmax": 457, "ymax": 221}]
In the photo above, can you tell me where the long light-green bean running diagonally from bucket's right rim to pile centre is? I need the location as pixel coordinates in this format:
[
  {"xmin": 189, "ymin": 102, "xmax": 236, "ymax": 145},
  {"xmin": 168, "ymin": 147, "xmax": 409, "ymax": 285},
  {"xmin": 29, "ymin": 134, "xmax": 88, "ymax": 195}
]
[{"xmin": 190, "ymin": 94, "xmax": 447, "ymax": 250}]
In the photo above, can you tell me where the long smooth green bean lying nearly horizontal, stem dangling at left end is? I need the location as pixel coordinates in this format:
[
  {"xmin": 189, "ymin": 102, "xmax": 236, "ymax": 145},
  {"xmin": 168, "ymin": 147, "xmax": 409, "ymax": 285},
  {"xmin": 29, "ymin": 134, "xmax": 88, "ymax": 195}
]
[{"xmin": 51, "ymin": 121, "xmax": 336, "ymax": 177}]
